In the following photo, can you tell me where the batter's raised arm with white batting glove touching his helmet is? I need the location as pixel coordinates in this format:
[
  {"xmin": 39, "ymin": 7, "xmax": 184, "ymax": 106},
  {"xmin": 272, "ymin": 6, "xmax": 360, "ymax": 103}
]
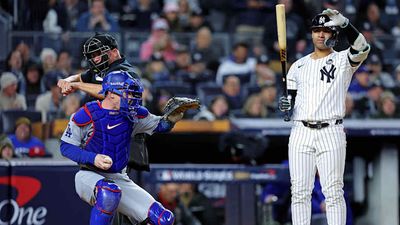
[{"xmin": 322, "ymin": 9, "xmax": 371, "ymax": 66}]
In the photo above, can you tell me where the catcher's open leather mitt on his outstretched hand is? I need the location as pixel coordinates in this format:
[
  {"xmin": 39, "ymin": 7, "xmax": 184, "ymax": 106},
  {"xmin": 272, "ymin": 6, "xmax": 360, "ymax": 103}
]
[{"xmin": 164, "ymin": 97, "xmax": 200, "ymax": 118}]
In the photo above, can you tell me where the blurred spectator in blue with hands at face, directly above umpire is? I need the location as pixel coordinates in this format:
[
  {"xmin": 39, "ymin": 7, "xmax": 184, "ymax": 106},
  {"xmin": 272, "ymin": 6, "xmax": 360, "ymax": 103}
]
[{"xmin": 76, "ymin": 0, "xmax": 119, "ymax": 32}]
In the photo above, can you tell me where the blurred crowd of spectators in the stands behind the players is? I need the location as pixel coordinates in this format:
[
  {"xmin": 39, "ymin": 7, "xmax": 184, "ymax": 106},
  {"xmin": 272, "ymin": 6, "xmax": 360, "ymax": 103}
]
[{"xmin": 0, "ymin": 0, "xmax": 400, "ymax": 148}]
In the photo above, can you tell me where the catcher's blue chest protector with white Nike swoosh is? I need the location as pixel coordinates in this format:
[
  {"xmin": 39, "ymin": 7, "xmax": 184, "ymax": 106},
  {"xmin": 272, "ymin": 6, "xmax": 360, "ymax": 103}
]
[{"xmin": 73, "ymin": 101, "xmax": 133, "ymax": 173}]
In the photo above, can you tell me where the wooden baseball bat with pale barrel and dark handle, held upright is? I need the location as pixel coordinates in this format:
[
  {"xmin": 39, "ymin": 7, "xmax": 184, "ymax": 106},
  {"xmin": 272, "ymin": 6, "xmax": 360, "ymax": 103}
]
[{"xmin": 275, "ymin": 4, "xmax": 290, "ymax": 121}]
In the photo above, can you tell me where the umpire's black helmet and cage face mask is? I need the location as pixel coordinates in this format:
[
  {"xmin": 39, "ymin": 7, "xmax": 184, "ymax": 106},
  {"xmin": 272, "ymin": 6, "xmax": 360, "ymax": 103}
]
[{"xmin": 83, "ymin": 34, "xmax": 118, "ymax": 77}]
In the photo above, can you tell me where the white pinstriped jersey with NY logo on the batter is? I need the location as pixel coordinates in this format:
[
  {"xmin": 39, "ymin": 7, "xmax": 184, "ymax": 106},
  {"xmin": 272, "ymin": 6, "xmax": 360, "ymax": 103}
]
[{"xmin": 287, "ymin": 50, "xmax": 358, "ymax": 121}]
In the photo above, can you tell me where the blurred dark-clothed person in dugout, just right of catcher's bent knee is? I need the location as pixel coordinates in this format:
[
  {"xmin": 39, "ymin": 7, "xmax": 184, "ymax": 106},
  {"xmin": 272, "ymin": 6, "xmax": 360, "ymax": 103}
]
[{"xmin": 179, "ymin": 183, "xmax": 218, "ymax": 225}]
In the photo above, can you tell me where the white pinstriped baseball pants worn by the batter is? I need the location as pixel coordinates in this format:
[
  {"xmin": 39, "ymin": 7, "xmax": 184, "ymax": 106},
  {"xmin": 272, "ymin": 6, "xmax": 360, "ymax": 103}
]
[{"xmin": 289, "ymin": 121, "xmax": 346, "ymax": 225}]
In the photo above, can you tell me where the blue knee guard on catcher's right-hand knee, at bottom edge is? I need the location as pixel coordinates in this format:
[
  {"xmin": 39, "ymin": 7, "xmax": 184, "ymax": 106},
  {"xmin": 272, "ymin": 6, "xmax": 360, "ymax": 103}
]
[{"xmin": 147, "ymin": 202, "xmax": 175, "ymax": 225}]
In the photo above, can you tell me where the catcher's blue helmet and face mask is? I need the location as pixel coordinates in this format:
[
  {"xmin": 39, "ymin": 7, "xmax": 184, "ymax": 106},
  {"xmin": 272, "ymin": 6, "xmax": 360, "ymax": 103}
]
[{"xmin": 99, "ymin": 71, "xmax": 143, "ymax": 122}]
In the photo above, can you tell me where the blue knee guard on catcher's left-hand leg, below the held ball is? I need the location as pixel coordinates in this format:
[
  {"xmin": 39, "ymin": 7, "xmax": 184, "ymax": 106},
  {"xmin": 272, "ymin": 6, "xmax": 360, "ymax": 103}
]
[{"xmin": 94, "ymin": 179, "xmax": 121, "ymax": 215}]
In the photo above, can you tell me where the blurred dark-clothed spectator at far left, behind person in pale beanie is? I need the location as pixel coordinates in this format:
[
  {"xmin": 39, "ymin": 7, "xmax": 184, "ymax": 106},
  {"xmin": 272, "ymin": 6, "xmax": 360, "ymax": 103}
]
[{"xmin": 6, "ymin": 50, "xmax": 26, "ymax": 95}]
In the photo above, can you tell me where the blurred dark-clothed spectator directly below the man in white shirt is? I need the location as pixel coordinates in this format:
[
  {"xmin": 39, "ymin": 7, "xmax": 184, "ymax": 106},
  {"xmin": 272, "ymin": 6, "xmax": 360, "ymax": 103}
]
[{"xmin": 222, "ymin": 76, "xmax": 244, "ymax": 110}]
